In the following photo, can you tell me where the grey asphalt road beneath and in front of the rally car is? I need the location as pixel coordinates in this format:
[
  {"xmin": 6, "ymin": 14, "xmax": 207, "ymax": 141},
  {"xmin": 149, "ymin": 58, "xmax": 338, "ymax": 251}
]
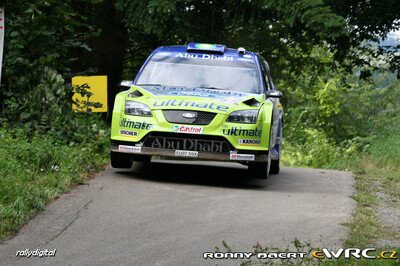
[{"xmin": 0, "ymin": 161, "xmax": 355, "ymax": 265}]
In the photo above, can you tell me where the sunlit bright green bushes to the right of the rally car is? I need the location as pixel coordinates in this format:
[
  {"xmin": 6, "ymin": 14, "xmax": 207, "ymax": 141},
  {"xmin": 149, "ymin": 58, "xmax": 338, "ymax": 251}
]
[{"xmin": 278, "ymin": 39, "xmax": 400, "ymax": 167}]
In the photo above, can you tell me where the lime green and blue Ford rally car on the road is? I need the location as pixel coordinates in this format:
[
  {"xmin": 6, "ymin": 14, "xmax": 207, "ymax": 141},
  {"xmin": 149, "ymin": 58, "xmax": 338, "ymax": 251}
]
[{"xmin": 111, "ymin": 43, "xmax": 283, "ymax": 178}]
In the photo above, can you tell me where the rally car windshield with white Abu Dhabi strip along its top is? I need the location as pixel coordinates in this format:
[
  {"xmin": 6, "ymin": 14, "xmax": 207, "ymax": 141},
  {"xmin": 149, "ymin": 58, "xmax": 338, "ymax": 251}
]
[{"xmin": 135, "ymin": 52, "xmax": 260, "ymax": 93}]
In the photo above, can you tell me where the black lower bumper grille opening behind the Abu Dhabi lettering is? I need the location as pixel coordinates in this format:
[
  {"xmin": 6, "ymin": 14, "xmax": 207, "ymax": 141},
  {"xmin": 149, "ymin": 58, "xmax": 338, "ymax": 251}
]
[{"xmin": 143, "ymin": 133, "xmax": 232, "ymax": 153}]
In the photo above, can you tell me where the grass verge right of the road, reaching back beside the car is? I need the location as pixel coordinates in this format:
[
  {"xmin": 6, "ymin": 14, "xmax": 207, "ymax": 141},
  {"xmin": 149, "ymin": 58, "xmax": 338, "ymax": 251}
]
[{"xmin": 283, "ymin": 129, "xmax": 400, "ymax": 247}]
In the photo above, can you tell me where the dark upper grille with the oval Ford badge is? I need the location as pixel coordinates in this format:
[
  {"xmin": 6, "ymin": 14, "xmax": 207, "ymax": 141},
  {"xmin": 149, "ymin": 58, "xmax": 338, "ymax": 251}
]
[{"xmin": 163, "ymin": 110, "xmax": 217, "ymax": 125}]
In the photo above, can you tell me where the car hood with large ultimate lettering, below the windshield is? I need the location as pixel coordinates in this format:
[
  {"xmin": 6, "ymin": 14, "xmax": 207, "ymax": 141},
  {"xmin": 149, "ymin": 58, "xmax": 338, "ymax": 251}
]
[{"xmin": 129, "ymin": 86, "xmax": 263, "ymax": 113}]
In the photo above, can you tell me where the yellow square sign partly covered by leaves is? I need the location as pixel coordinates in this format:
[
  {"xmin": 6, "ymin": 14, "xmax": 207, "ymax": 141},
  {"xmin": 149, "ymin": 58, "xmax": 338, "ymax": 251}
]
[{"xmin": 72, "ymin": 76, "xmax": 107, "ymax": 112}]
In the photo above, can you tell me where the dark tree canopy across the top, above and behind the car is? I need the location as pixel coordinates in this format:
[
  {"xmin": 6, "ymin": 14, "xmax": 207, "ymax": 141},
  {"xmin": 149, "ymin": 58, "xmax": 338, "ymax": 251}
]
[{"xmin": 0, "ymin": 0, "xmax": 398, "ymax": 115}]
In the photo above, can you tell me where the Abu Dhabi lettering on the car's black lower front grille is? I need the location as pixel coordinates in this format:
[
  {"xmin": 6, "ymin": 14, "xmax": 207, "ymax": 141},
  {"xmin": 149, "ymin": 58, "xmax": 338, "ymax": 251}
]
[{"xmin": 147, "ymin": 137, "xmax": 223, "ymax": 153}]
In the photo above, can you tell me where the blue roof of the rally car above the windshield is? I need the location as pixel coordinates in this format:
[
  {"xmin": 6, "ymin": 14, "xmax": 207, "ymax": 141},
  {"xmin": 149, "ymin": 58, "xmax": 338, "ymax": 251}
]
[{"xmin": 153, "ymin": 43, "xmax": 256, "ymax": 59}]
